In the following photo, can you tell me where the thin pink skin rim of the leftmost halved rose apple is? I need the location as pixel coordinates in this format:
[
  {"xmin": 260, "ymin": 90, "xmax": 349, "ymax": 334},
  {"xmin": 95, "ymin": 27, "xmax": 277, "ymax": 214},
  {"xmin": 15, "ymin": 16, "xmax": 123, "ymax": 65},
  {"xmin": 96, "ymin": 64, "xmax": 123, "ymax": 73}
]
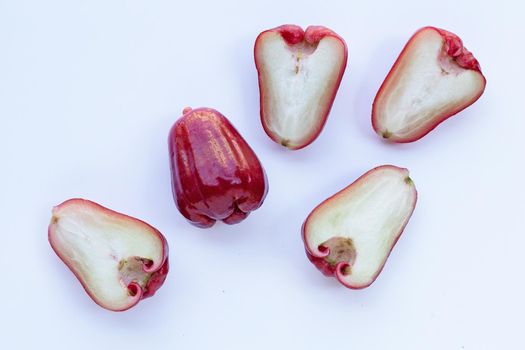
[{"xmin": 47, "ymin": 198, "xmax": 169, "ymax": 312}]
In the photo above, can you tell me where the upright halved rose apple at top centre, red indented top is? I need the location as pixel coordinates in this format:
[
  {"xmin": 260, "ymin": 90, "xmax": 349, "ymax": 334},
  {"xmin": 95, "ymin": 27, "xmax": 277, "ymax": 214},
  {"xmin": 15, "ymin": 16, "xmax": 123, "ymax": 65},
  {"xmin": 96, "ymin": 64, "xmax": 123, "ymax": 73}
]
[{"xmin": 254, "ymin": 25, "xmax": 347, "ymax": 149}]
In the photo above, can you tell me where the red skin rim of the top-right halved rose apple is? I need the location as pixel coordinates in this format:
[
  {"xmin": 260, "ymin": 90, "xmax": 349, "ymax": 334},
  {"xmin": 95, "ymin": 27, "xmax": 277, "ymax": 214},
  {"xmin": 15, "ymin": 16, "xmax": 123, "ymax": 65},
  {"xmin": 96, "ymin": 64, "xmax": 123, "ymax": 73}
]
[{"xmin": 372, "ymin": 26, "xmax": 487, "ymax": 143}]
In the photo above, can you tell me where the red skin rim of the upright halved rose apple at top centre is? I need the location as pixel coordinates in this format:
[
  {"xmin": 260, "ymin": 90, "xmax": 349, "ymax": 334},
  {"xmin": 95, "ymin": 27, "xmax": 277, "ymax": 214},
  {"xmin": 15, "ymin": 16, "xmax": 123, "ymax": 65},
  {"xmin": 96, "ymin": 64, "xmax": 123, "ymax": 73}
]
[{"xmin": 253, "ymin": 24, "xmax": 348, "ymax": 150}]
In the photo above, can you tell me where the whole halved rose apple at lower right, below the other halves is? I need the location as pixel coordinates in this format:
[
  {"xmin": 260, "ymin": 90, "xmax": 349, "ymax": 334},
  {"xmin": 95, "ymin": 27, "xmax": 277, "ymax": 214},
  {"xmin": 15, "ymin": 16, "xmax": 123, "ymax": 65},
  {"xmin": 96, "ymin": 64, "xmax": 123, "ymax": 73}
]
[{"xmin": 302, "ymin": 165, "xmax": 417, "ymax": 289}]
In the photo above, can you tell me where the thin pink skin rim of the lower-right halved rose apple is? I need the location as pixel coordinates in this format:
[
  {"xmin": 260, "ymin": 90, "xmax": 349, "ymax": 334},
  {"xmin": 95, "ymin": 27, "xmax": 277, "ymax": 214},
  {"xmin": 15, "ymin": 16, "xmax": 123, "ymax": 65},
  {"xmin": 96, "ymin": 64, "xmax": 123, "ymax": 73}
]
[{"xmin": 301, "ymin": 165, "xmax": 417, "ymax": 289}]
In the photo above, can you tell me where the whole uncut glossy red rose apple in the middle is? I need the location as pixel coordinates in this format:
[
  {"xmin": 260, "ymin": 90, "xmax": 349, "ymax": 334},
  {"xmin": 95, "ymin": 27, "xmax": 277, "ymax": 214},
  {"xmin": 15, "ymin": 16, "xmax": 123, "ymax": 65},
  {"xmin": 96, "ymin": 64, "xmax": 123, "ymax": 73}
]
[{"xmin": 168, "ymin": 108, "xmax": 268, "ymax": 228}]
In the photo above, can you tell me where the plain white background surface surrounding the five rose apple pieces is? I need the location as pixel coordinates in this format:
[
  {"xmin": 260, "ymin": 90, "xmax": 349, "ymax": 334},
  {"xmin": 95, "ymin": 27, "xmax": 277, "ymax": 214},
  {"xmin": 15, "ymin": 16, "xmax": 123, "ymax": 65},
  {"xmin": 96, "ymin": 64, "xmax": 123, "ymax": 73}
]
[{"xmin": 0, "ymin": 0, "xmax": 525, "ymax": 350}]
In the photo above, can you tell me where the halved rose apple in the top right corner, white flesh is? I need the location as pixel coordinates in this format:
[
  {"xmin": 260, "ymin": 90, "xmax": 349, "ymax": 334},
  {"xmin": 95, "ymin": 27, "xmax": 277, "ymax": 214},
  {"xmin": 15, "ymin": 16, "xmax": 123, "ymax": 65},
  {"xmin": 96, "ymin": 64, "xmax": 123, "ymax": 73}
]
[{"xmin": 372, "ymin": 27, "xmax": 486, "ymax": 142}]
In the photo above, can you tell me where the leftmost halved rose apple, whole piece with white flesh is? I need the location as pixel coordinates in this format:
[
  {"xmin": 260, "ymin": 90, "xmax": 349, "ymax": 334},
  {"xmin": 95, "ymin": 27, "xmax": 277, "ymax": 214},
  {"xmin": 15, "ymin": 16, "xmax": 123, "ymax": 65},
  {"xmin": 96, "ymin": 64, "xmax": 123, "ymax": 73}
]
[{"xmin": 48, "ymin": 199, "xmax": 168, "ymax": 311}]
